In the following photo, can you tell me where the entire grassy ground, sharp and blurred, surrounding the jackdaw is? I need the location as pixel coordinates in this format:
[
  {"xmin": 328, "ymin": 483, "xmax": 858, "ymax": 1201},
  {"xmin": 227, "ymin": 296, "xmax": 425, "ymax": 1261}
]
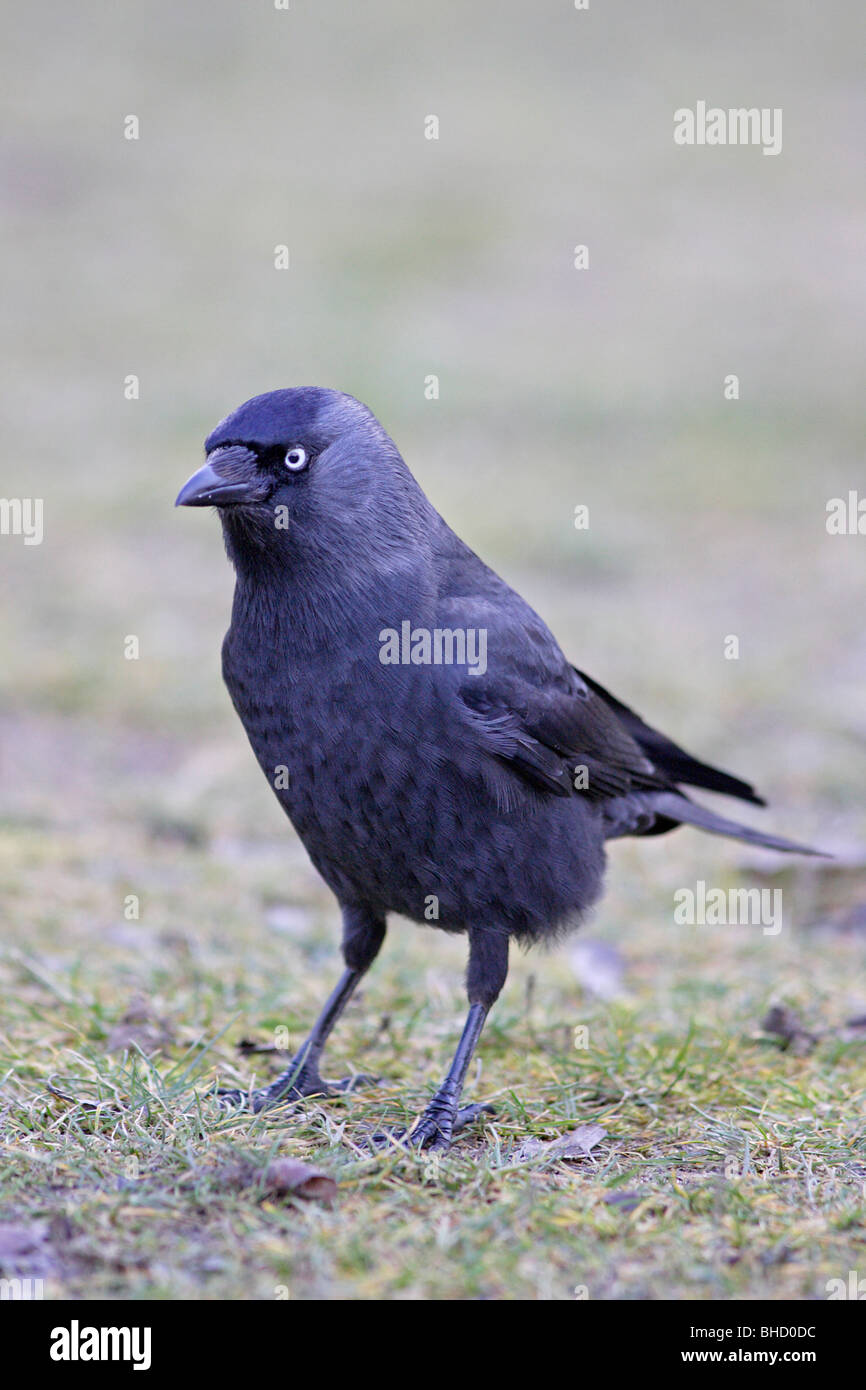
[{"xmin": 0, "ymin": 0, "xmax": 866, "ymax": 1300}]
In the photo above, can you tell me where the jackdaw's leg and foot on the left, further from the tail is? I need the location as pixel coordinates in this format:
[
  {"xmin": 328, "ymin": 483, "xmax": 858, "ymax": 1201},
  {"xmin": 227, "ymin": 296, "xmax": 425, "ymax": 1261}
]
[{"xmin": 220, "ymin": 906, "xmax": 385, "ymax": 1111}]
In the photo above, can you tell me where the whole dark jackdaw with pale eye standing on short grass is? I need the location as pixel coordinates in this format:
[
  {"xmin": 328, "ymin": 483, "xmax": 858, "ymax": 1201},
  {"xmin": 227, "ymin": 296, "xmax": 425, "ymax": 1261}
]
[{"xmin": 175, "ymin": 386, "xmax": 819, "ymax": 1151}]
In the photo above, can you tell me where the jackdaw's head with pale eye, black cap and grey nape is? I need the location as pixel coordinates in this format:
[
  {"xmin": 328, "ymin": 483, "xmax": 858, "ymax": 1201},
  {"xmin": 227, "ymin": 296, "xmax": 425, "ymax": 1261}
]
[{"xmin": 175, "ymin": 386, "xmax": 435, "ymax": 569}]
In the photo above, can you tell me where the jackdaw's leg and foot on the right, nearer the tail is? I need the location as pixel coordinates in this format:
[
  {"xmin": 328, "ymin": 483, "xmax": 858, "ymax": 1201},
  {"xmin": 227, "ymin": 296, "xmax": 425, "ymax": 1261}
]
[{"xmin": 407, "ymin": 929, "xmax": 509, "ymax": 1150}]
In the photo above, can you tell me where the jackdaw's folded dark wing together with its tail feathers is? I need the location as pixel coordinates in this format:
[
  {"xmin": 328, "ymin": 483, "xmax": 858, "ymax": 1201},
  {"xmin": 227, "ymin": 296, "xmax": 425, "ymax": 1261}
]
[{"xmin": 439, "ymin": 545, "xmax": 817, "ymax": 853}]
